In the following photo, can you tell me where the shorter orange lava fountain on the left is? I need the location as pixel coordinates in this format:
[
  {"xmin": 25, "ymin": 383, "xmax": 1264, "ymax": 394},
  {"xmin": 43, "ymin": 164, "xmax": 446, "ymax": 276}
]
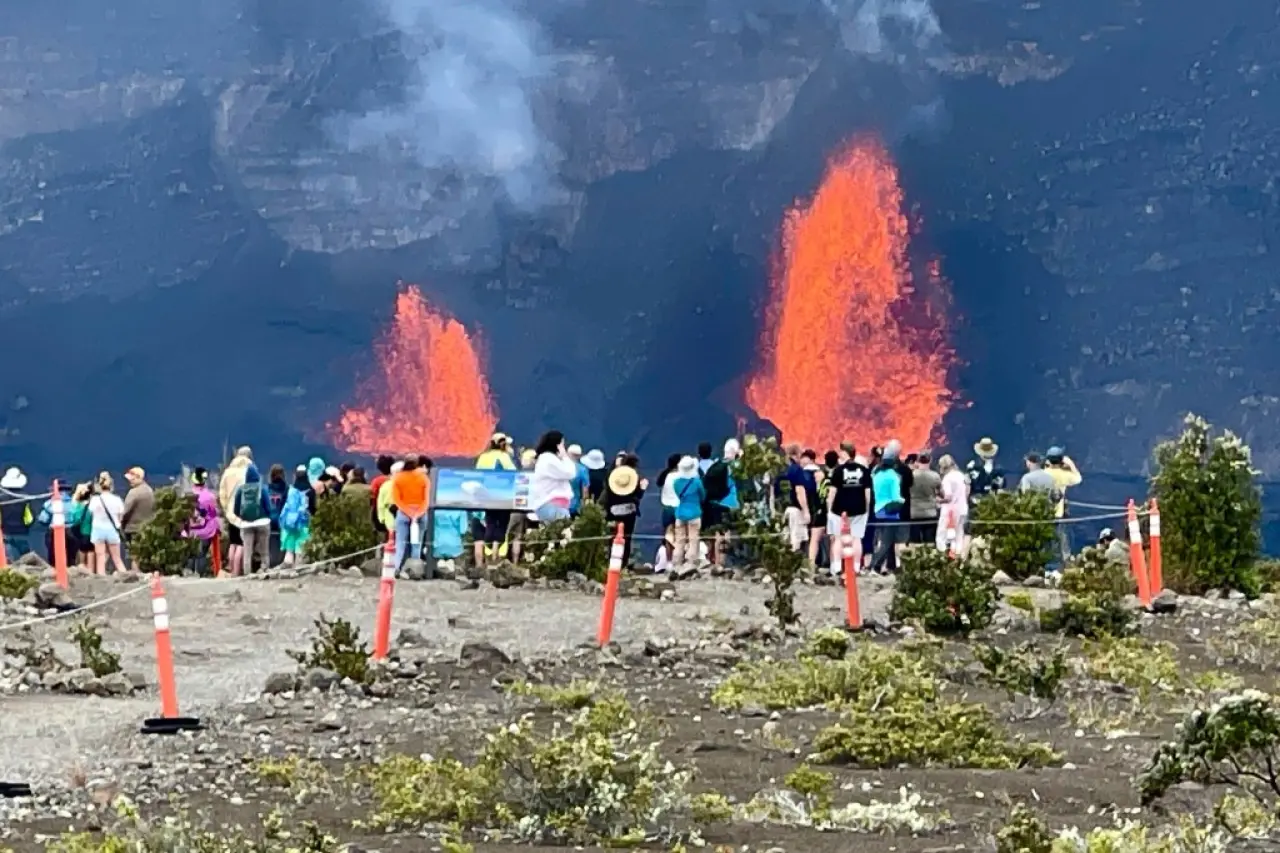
[{"xmin": 335, "ymin": 287, "xmax": 498, "ymax": 456}]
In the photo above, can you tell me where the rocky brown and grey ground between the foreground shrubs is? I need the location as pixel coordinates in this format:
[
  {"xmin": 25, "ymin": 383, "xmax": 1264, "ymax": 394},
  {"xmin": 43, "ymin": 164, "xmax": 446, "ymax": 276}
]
[{"xmin": 0, "ymin": 550, "xmax": 1280, "ymax": 853}]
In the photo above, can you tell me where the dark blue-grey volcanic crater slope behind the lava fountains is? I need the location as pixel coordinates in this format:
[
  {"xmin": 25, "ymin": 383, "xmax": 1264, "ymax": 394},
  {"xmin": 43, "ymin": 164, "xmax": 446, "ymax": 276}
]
[{"xmin": 0, "ymin": 0, "xmax": 1280, "ymax": 473}]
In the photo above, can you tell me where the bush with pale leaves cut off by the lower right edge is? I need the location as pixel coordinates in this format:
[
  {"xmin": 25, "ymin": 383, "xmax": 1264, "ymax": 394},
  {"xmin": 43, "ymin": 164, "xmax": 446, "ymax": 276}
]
[{"xmin": 1138, "ymin": 690, "xmax": 1280, "ymax": 808}]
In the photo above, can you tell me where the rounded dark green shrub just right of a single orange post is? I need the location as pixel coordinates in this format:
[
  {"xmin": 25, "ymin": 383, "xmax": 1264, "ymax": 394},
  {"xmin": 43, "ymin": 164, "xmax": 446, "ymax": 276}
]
[{"xmin": 890, "ymin": 547, "xmax": 1000, "ymax": 634}]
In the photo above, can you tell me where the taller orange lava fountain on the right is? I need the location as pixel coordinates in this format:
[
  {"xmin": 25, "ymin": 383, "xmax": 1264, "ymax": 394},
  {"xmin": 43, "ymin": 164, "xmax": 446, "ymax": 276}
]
[{"xmin": 746, "ymin": 138, "xmax": 955, "ymax": 452}]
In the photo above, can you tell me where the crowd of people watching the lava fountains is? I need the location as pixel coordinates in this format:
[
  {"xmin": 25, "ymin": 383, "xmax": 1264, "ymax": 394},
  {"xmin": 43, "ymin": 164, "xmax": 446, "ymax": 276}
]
[{"xmin": 0, "ymin": 430, "xmax": 1082, "ymax": 576}]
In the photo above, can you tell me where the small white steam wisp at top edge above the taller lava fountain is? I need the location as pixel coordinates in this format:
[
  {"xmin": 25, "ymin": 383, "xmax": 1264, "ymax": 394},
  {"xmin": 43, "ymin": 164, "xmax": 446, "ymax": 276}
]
[{"xmin": 822, "ymin": 0, "xmax": 942, "ymax": 63}]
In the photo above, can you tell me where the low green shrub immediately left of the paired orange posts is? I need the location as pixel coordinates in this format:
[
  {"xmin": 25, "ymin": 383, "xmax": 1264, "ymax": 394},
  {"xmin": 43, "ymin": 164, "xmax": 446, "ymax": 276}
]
[{"xmin": 1041, "ymin": 546, "xmax": 1134, "ymax": 638}]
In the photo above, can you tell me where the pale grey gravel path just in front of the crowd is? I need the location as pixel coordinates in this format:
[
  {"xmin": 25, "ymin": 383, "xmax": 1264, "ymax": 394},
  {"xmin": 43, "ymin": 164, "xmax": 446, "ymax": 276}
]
[{"xmin": 0, "ymin": 575, "xmax": 890, "ymax": 783}]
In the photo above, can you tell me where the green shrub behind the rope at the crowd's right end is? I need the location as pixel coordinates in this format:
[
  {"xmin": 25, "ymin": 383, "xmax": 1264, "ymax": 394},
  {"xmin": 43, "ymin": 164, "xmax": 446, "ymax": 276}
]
[{"xmin": 972, "ymin": 492, "xmax": 1057, "ymax": 580}]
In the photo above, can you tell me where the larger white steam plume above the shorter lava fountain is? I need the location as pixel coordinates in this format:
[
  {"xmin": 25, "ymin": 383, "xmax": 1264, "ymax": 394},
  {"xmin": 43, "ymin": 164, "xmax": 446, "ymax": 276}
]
[{"xmin": 329, "ymin": 0, "xmax": 562, "ymax": 211}]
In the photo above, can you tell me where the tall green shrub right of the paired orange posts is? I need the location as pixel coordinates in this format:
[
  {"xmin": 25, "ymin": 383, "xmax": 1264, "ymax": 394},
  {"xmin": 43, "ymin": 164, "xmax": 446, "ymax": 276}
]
[{"xmin": 1151, "ymin": 415, "xmax": 1262, "ymax": 596}]
